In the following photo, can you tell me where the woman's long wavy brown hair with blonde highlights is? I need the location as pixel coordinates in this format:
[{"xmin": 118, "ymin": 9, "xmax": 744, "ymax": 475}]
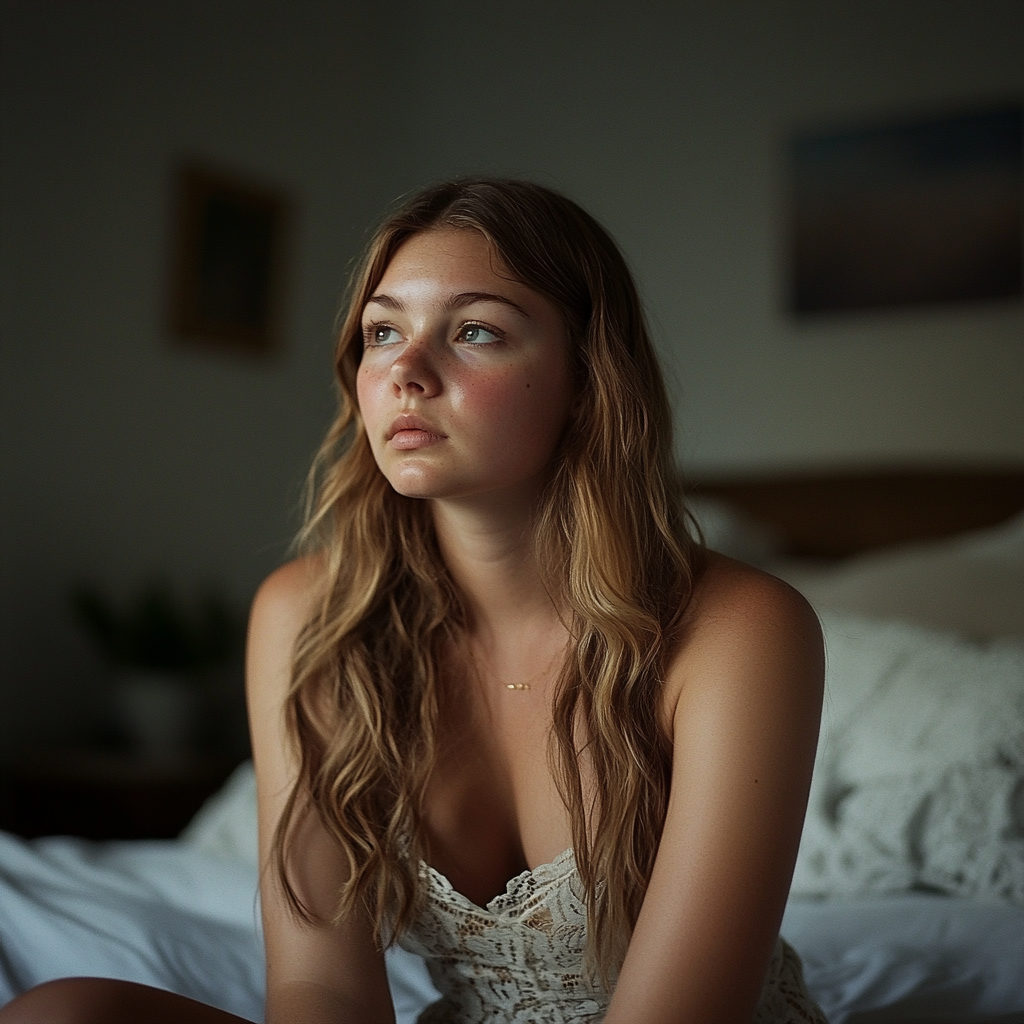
[{"xmin": 273, "ymin": 179, "xmax": 701, "ymax": 988}]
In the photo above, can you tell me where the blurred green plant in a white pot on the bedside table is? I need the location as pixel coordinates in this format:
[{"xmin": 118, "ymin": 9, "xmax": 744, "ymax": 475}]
[{"xmin": 73, "ymin": 584, "xmax": 241, "ymax": 757}]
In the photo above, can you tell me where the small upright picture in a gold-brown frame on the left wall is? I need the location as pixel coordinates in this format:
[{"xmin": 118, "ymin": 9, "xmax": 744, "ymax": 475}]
[{"xmin": 170, "ymin": 163, "xmax": 291, "ymax": 353}]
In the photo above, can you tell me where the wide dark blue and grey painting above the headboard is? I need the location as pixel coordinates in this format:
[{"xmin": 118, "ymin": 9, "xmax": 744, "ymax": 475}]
[{"xmin": 788, "ymin": 101, "xmax": 1022, "ymax": 315}]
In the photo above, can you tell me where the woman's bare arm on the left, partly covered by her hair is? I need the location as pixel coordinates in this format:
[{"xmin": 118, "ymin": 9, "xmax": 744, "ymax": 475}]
[{"xmin": 246, "ymin": 559, "xmax": 394, "ymax": 1024}]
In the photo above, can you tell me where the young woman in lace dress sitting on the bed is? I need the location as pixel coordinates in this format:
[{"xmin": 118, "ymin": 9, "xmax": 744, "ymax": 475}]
[{"xmin": 0, "ymin": 179, "xmax": 823, "ymax": 1024}]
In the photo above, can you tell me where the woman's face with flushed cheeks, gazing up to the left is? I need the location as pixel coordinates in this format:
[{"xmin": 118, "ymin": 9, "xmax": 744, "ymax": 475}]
[{"xmin": 356, "ymin": 228, "xmax": 572, "ymax": 499}]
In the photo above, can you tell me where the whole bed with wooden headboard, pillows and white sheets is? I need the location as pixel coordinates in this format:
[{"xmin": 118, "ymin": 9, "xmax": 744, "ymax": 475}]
[{"xmin": 0, "ymin": 472, "xmax": 1024, "ymax": 1024}]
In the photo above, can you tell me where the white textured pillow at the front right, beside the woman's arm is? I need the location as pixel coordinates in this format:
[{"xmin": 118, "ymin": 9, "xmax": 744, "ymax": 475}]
[{"xmin": 793, "ymin": 612, "xmax": 1024, "ymax": 902}]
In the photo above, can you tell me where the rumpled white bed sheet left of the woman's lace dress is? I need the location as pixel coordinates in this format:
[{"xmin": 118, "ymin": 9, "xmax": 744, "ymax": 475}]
[{"xmin": 0, "ymin": 833, "xmax": 437, "ymax": 1024}]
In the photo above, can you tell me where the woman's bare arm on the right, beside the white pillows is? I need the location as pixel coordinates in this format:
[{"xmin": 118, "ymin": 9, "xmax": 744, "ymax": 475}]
[{"xmin": 605, "ymin": 558, "xmax": 824, "ymax": 1024}]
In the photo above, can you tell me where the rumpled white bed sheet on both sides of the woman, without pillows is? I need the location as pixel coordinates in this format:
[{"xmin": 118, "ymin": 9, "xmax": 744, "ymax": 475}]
[{"xmin": 0, "ymin": 834, "xmax": 1024, "ymax": 1024}]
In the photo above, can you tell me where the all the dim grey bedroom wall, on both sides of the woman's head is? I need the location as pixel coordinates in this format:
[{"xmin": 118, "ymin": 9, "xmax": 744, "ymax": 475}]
[{"xmin": 0, "ymin": 0, "xmax": 1024, "ymax": 750}]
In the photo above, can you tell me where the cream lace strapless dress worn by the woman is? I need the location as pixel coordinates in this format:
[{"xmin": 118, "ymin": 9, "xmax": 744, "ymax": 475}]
[{"xmin": 399, "ymin": 850, "xmax": 826, "ymax": 1024}]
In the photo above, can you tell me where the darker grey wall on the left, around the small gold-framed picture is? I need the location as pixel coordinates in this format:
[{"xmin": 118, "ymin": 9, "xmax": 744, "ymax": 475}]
[{"xmin": 0, "ymin": 0, "xmax": 415, "ymax": 750}]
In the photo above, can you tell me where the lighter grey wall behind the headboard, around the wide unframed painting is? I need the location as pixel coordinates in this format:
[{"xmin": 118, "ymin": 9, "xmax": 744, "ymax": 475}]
[{"xmin": 391, "ymin": 0, "xmax": 1024, "ymax": 473}]
